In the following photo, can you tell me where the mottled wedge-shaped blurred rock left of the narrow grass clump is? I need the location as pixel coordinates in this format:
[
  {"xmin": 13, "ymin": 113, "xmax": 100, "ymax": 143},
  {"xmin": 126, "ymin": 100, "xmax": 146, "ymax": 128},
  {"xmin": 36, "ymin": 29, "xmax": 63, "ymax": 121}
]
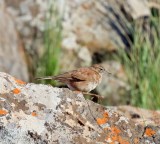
[{"xmin": 5, "ymin": 0, "xmax": 50, "ymax": 81}]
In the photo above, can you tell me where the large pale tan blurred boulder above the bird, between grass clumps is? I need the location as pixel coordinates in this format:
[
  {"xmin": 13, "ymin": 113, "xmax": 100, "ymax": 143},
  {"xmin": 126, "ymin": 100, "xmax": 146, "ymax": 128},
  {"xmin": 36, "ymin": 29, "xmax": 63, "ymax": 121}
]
[{"xmin": 63, "ymin": 0, "xmax": 150, "ymax": 52}]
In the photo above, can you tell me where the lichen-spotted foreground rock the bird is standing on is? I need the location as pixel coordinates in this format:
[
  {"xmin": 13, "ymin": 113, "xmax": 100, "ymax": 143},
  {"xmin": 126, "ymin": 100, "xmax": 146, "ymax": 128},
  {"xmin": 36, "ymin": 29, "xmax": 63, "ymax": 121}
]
[{"xmin": 0, "ymin": 73, "xmax": 160, "ymax": 144}]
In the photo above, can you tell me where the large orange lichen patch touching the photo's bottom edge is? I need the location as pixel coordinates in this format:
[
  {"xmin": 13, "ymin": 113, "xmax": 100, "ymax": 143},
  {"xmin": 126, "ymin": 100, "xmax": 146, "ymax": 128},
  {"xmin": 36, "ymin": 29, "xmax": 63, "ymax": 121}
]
[{"xmin": 106, "ymin": 126, "xmax": 129, "ymax": 144}]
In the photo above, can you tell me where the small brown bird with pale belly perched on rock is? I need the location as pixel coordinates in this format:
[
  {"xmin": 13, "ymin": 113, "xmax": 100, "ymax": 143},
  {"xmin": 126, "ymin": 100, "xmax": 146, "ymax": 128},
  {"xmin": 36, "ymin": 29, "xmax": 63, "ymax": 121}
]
[{"xmin": 36, "ymin": 64, "xmax": 110, "ymax": 92}]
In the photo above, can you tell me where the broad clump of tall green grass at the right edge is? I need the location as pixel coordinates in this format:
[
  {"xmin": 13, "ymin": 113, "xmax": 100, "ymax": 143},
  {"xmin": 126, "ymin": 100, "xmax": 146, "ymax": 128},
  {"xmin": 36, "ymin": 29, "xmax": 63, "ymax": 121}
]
[{"xmin": 120, "ymin": 11, "xmax": 160, "ymax": 109}]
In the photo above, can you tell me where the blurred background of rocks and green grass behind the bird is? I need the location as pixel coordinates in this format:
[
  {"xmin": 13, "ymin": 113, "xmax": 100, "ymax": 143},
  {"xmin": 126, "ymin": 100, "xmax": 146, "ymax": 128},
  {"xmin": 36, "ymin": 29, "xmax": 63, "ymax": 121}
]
[{"xmin": 0, "ymin": 0, "xmax": 160, "ymax": 109}]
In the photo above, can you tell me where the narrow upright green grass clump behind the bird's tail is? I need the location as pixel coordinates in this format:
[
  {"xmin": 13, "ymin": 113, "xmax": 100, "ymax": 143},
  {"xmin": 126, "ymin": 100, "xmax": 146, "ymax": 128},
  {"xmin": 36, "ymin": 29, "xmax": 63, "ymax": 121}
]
[{"xmin": 37, "ymin": 0, "xmax": 62, "ymax": 85}]
